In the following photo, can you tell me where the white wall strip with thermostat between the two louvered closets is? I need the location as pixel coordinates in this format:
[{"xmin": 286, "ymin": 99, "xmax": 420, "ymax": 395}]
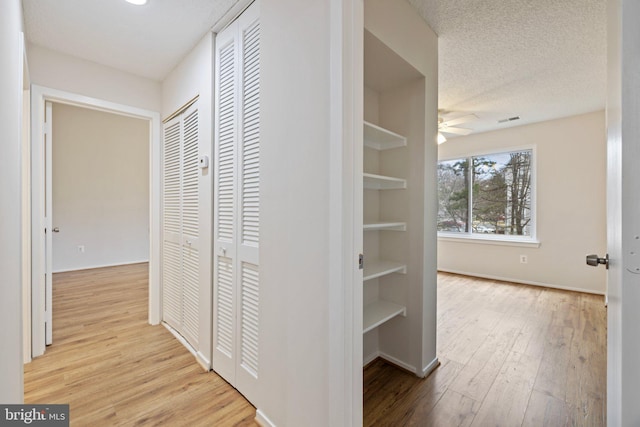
[{"xmin": 161, "ymin": 33, "xmax": 213, "ymax": 367}]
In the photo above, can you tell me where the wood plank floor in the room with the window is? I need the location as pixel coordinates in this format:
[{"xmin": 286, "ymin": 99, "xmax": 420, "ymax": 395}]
[{"xmin": 364, "ymin": 273, "xmax": 607, "ymax": 427}]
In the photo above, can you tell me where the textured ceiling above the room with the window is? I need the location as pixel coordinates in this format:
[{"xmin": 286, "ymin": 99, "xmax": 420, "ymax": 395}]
[{"xmin": 410, "ymin": 0, "xmax": 606, "ymax": 132}]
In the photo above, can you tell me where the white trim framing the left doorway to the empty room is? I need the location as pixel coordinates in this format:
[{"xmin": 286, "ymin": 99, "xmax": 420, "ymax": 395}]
[{"xmin": 31, "ymin": 85, "xmax": 161, "ymax": 357}]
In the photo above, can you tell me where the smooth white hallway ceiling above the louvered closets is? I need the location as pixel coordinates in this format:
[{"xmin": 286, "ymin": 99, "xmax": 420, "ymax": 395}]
[{"xmin": 22, "ymin": 0, "xmax": 238, "ymax": 81}]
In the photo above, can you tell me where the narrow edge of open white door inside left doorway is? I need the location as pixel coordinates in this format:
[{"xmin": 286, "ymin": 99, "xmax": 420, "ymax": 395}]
[{"xmin": 44, "ymin": 101, "xmax": 53, "ymax": 345}]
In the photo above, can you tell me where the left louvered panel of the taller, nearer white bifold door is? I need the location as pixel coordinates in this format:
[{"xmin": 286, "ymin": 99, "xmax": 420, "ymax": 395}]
[{"xmin": 212, "ymin": 20, "xmax": 238, "ymax": 385}]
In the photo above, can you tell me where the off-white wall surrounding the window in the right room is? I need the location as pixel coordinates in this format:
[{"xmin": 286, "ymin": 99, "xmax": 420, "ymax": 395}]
[{"xmin": 438, "ymin": 111, "xmax": 606, "ymax": 293}]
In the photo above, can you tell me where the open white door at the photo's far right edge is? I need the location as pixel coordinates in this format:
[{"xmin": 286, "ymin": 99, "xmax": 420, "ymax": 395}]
[{"xmin": 607, "ymin": 0, "xmax": 640, "ymax": 426}]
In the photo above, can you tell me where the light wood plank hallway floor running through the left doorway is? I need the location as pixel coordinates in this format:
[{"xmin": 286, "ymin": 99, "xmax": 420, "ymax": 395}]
[{"xmin": 24, "ymin": 264, "xmax": 257, "ymax": 426}]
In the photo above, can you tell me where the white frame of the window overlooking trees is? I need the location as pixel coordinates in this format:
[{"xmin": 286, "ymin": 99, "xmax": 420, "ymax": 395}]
[{"xmin": 438, "ymin": 145, "xmax": 540, "ymax": 248}]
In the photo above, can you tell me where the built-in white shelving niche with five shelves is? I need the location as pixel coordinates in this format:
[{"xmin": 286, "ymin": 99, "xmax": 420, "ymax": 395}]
[{"xmin": 362, "ymin": 23, "xmax": 437, "ymax": 376}]
